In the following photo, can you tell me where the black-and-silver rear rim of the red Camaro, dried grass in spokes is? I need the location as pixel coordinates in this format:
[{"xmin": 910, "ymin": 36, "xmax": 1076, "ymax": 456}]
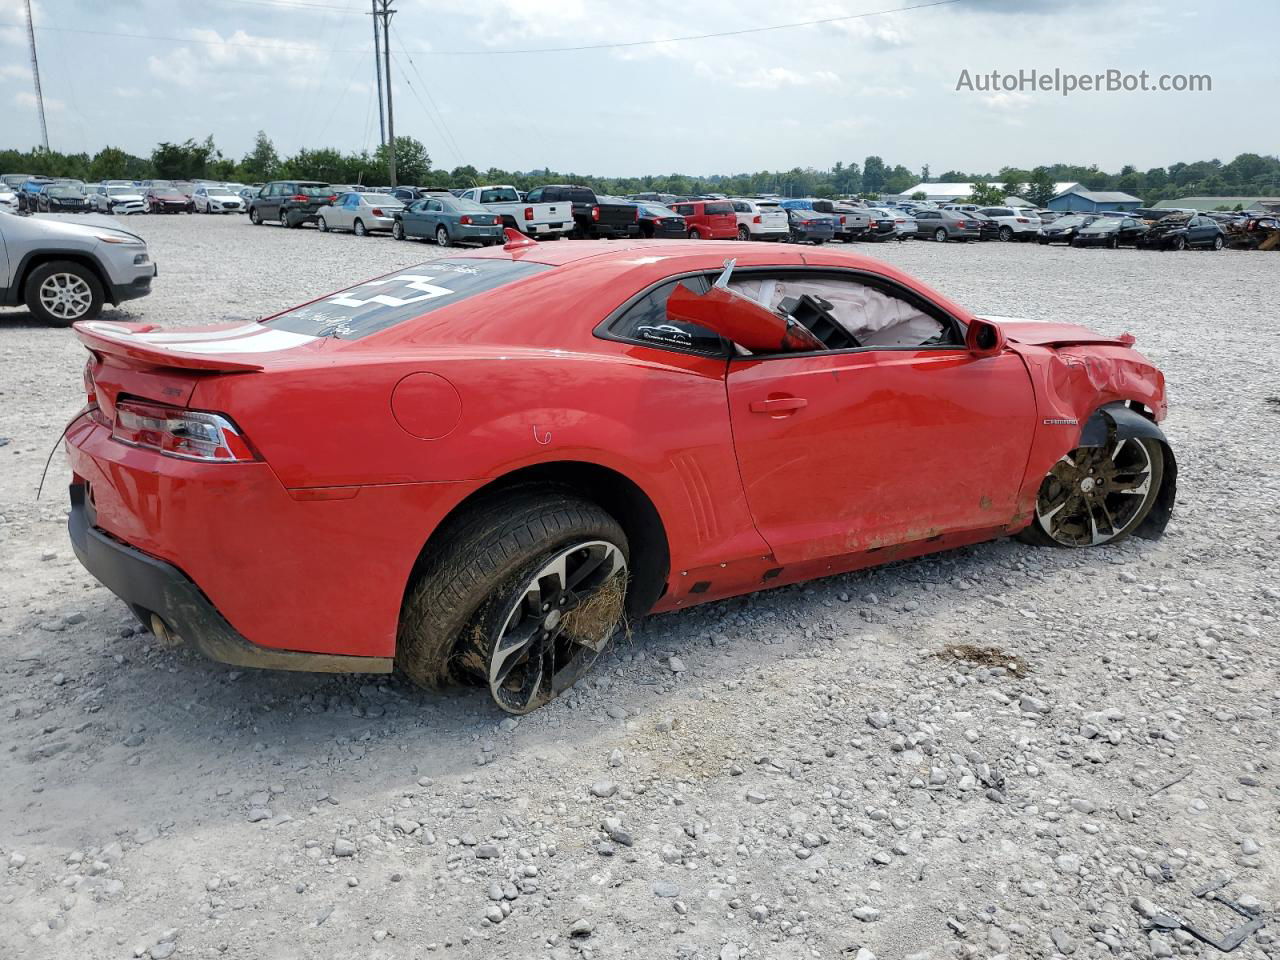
[{"xmin": 488, "ymin": 540, "xmax": 627, "ymax": 713}]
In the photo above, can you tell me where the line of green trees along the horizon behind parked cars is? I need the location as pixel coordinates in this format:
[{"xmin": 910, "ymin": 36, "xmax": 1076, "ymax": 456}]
[{"xmin": 0, "ymin": 131, "xmax": 1280, "ymax": 206}]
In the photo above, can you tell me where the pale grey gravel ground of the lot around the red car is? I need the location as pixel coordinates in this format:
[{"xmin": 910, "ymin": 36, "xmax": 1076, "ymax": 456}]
[{"xmin": 0, "ymin": 218, "xmax": 1280, "ymax": 960}]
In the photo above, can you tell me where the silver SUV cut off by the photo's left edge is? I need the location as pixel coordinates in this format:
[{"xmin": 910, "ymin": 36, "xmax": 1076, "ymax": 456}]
[{"xmin": 0, "ymin": 212, "xmax": 156, "ymax": 326}]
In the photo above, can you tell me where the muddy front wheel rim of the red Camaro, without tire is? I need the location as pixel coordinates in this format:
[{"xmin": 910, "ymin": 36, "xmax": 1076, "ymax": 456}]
[{"xmin": 1036, "ymin": 436, "xmax": 1156, "ymax": 547}]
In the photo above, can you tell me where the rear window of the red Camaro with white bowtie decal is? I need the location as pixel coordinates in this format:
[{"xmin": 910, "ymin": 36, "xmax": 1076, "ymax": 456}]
[{"xmin": 262, "ymin": 260, "xmax": 552, "ymax": 340}]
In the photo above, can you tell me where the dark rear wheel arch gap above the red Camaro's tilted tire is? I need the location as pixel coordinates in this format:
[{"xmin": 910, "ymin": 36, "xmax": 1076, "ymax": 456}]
[{"xmin": 404, "ymin": 461, "xmax": 671, "ymax": 617}]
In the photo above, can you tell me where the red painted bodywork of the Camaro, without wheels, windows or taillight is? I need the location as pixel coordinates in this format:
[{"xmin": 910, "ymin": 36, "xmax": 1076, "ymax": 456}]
[{"xmin": 67, "ymin": 241, "xmax": 1165, "ymax": 657}]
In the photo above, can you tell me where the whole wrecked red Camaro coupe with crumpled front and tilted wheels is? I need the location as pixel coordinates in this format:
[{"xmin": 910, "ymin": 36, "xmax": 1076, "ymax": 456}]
[{"xmin": 67, "ymin": 234, "xmax": 1176, "ymax": 713}]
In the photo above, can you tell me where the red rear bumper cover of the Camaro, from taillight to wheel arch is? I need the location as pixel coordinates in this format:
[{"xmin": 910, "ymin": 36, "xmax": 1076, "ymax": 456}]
[{"xmin": 65, "ymin": 416, "xmax": 483, "ymax": 671}]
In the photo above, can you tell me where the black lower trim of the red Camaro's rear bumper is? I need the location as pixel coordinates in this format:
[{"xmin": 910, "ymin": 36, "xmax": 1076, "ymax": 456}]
[{"xmin": 67, "ymin": 483, "xmax": 394, "ymax": 673}]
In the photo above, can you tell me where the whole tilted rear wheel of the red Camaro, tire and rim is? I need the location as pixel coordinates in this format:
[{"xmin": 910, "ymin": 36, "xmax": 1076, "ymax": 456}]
[{"xmin": 396, "ymin": 489, "xmax": 628, "ymax": 714}]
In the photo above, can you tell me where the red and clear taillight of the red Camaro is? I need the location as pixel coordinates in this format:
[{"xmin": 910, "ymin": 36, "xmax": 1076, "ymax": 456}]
[{"xmin": 111, "ymin": 399, "xmax": 259, "ymax": 463}]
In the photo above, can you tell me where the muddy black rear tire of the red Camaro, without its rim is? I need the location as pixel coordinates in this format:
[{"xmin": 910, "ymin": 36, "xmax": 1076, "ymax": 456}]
[{"xmin": 396, "ymin": 486, "xmax": 630, "ymax": 711}]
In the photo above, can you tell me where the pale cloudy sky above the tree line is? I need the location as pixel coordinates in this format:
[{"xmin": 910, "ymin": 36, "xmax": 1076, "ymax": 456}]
[{"xmin": 0, "ymin": 0, "xmax": 1280, "ymax": 175}]
